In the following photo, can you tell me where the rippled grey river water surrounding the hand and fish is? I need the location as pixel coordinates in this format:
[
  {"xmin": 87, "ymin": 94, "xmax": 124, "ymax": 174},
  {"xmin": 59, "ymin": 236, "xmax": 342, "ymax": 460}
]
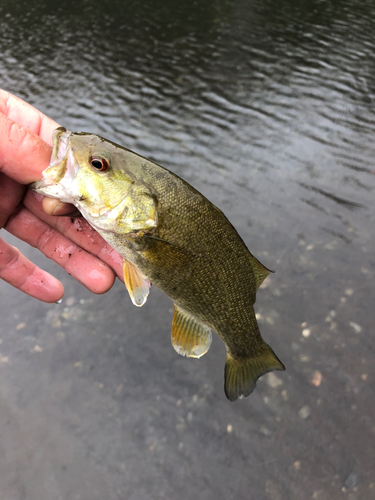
[{"xmin": 0, "ymin": 0, "xmax": 375, "ymax": 500}]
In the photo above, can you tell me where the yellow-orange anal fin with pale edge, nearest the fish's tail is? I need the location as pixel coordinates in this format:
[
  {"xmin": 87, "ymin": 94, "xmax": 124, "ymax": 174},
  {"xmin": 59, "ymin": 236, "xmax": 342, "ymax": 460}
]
[{"xmin": 171, "ymin": 304, "xmax": 212, "ymax": 358}]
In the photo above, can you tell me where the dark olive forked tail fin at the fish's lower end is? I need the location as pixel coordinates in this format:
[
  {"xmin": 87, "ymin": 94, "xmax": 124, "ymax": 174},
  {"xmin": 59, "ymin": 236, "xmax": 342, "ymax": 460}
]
[{"xmin": 224, "ymin": 343, "xmax": 285, "ymax": 401}]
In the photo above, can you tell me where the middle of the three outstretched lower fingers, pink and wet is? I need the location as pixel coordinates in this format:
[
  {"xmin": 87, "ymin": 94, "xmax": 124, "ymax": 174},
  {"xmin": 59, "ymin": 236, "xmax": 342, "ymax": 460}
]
[{"xmin": 5, "ymin": 208, "xmax": 115, "ymax": 293}]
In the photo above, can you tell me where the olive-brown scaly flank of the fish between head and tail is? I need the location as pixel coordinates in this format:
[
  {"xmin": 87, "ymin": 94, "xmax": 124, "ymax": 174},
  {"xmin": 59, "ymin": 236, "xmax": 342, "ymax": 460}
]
[{"xmin": 117, "ymin": 165, "xmax": 255, "ymax": 340}]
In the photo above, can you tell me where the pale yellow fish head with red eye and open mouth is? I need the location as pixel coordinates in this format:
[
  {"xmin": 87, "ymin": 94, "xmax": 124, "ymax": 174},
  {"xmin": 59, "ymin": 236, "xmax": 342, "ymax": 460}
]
[{"xmin": 30, "ymin": 127, "xmax": 157, "ymax": 234}]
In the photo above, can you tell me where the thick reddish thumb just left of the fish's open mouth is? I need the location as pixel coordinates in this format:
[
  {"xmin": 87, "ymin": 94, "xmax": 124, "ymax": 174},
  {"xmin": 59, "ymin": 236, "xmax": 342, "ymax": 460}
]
[{"xmin": 0, "ymin": 110, "xmax": 52, "ymax": 184}]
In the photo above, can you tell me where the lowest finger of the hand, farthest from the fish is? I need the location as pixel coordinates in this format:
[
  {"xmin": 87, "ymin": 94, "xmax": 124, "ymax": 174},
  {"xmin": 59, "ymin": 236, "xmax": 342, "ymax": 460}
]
[{"xmin": 0, "ymin": 234, "xmax": 64, "ymax": 302}]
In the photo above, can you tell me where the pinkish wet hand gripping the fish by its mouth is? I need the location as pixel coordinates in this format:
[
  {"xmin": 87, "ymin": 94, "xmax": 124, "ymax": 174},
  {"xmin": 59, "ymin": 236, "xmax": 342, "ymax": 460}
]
[{"xmin": 0, "ymin": 89, "xmax": 122, "ymax": 302}]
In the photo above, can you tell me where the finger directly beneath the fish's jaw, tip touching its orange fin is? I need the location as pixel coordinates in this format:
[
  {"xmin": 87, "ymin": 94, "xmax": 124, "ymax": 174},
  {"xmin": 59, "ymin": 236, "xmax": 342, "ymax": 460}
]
[{"xmin": 23, "ymin": 190, "xmax": 123, "ymax": 281}]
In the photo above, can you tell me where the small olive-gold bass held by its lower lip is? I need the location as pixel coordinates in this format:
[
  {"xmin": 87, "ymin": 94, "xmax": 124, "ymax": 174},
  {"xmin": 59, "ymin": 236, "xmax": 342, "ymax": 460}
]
[{"xmin": 30, "ymin": 127, "xmax": 285, "ymax": 401}]
